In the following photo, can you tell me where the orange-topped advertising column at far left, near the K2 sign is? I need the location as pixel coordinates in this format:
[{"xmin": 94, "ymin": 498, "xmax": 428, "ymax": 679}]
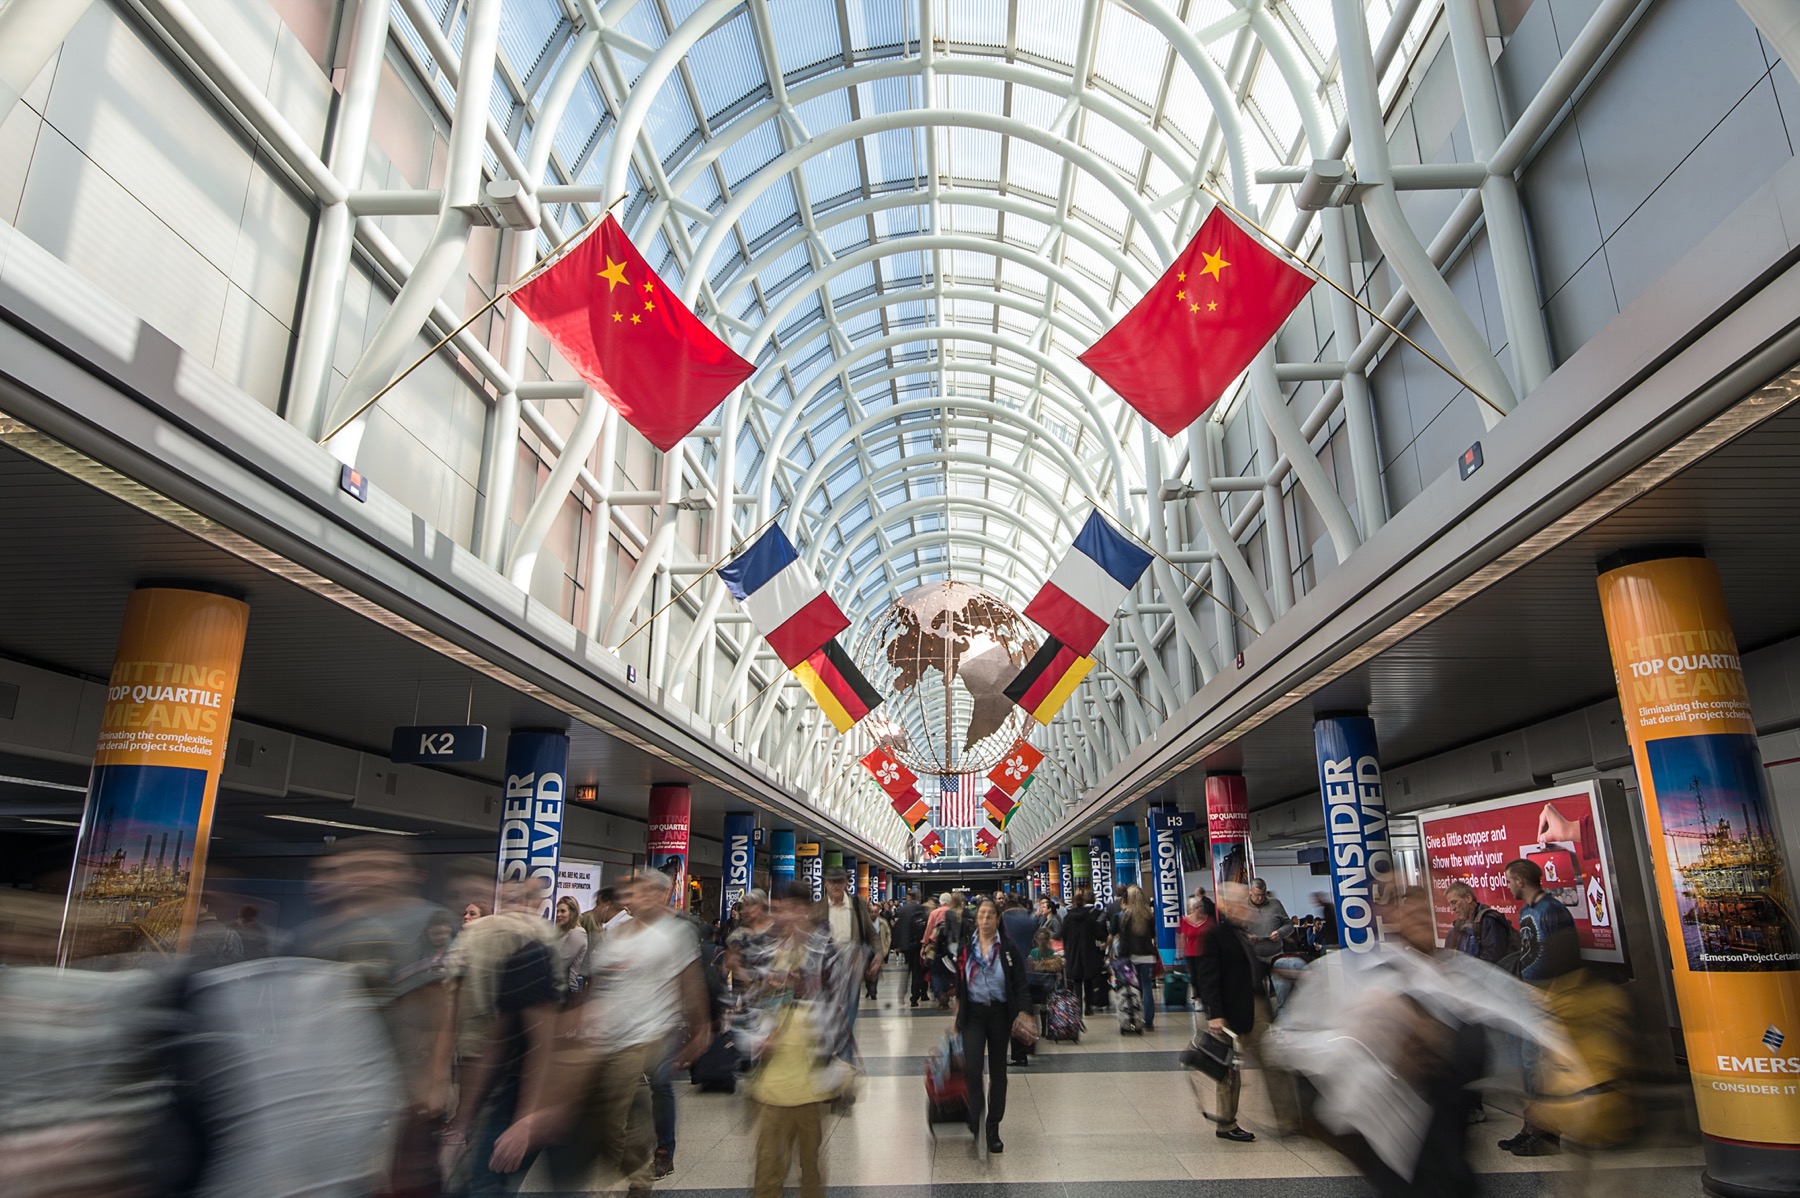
[{"xmin": 59, "ymin": 586, "xmax": 250, "ymax": 962}]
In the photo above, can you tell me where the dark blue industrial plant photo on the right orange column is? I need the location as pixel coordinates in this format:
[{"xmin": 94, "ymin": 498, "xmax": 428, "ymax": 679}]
[{"xmin": 1647, "ymin": 736, "xmax": 1800, "ymax": 973}]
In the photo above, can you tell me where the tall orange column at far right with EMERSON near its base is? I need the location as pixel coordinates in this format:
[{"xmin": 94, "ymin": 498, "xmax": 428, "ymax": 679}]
[{"xmin": 1600, "ymin": 547, "xmax": 1800, "ymax": 1194}]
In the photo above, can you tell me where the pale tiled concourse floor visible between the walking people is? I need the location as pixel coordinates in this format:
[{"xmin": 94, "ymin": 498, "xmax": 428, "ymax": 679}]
[{"xmin": 526, "ymin": 971, "xmax": 1701, "ymax": 1198}]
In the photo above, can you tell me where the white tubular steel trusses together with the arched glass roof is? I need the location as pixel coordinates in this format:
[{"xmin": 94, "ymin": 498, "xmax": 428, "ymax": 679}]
[{"xmin": 0, "ymin": 0, "xmax": 1720, "ymax": 856}]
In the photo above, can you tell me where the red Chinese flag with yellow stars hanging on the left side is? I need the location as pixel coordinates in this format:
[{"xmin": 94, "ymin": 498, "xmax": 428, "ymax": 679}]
[{"xmin": 513, "ymin": 216, "xmax": 756, "ymax": 451}]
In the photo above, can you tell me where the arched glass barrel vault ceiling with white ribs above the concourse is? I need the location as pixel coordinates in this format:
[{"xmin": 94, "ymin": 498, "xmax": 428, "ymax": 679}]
[{"xmin": 408, "ymin": 0, "xmax": 1438, "ymax": 626}]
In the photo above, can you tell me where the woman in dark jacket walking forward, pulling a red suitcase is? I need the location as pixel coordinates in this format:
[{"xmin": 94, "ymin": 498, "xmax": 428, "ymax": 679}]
[{"xmin": 956, "ymin": 899, "xmax": 1035, "ymax": 1153}]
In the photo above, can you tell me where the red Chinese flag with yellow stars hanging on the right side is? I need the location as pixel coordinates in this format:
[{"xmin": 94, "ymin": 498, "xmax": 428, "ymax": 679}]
[{"xmin": 1080, "ymin": 209, "xmax": 1312, "ymax": 437}]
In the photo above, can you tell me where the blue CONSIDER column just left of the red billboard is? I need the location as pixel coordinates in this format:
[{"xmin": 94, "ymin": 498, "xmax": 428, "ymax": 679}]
[{"xmin": 1312, "ymin": 714, "xmax": 1393, "ymax": 953}]
